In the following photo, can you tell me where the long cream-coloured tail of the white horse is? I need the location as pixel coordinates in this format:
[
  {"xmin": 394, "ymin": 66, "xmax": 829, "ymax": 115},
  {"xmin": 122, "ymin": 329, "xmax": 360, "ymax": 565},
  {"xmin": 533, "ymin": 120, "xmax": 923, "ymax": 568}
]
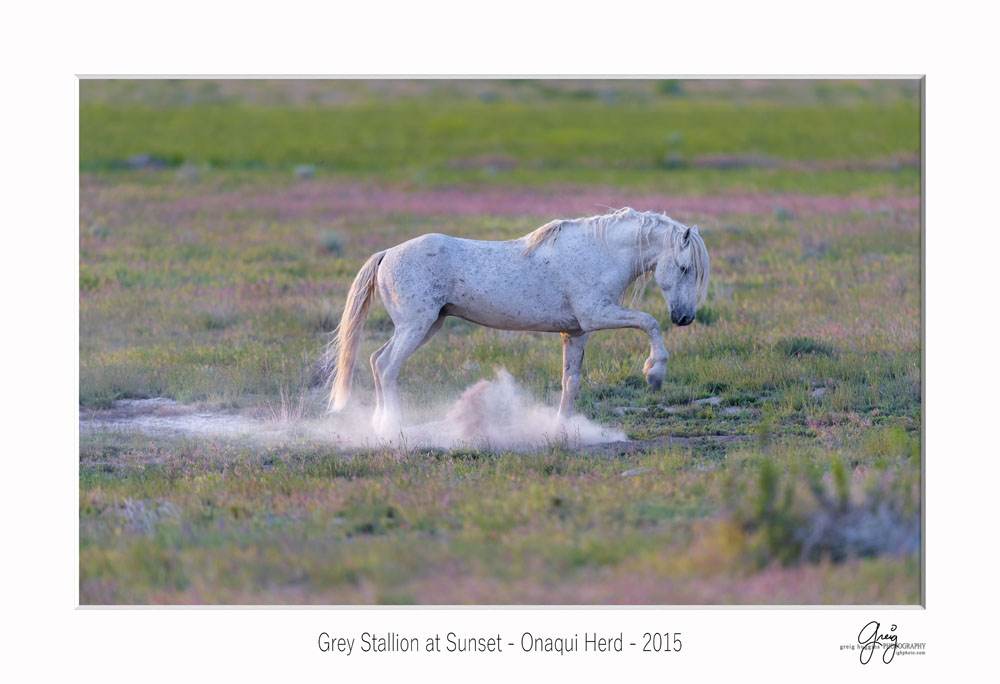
[{"xmin": 327, "ymin": 250, "xmax": 387, "ymax": 411}]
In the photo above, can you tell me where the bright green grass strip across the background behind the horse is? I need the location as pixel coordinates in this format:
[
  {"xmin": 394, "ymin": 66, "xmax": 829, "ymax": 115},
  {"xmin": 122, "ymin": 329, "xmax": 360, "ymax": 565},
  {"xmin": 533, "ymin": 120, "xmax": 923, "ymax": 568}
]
[{"xmin": 80, "ymin": 100, "xmax": 920, "ymax": 172}]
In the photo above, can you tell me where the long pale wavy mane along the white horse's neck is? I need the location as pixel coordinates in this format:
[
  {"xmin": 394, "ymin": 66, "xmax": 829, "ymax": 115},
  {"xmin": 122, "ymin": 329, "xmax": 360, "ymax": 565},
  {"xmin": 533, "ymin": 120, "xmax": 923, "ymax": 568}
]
[{"xmin": 524, "ymin": 207, "xmax": 709, "ymax": 306}]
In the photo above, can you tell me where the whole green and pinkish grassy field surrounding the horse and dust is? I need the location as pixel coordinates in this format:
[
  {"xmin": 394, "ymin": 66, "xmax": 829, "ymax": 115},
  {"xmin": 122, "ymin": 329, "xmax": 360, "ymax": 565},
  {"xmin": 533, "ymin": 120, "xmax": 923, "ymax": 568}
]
[{"xmin": 80, "ymin": 81, "xmax": 921, "ymax": 604}]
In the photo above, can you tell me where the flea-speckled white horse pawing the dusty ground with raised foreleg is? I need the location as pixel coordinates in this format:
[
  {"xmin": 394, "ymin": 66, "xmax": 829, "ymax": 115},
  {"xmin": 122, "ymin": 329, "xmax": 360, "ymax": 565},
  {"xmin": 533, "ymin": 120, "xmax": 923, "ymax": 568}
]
[{"xmin": 329, "ymin": 208, "xmax": 709, "ymax": 434}]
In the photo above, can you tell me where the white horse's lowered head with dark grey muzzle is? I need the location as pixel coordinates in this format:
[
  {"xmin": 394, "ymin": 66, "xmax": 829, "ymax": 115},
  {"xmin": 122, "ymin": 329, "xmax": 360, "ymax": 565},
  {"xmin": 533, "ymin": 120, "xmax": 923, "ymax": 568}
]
[{"xmin": 654, "ymin": 225, "xmax": 709, "ymax": 325}]
